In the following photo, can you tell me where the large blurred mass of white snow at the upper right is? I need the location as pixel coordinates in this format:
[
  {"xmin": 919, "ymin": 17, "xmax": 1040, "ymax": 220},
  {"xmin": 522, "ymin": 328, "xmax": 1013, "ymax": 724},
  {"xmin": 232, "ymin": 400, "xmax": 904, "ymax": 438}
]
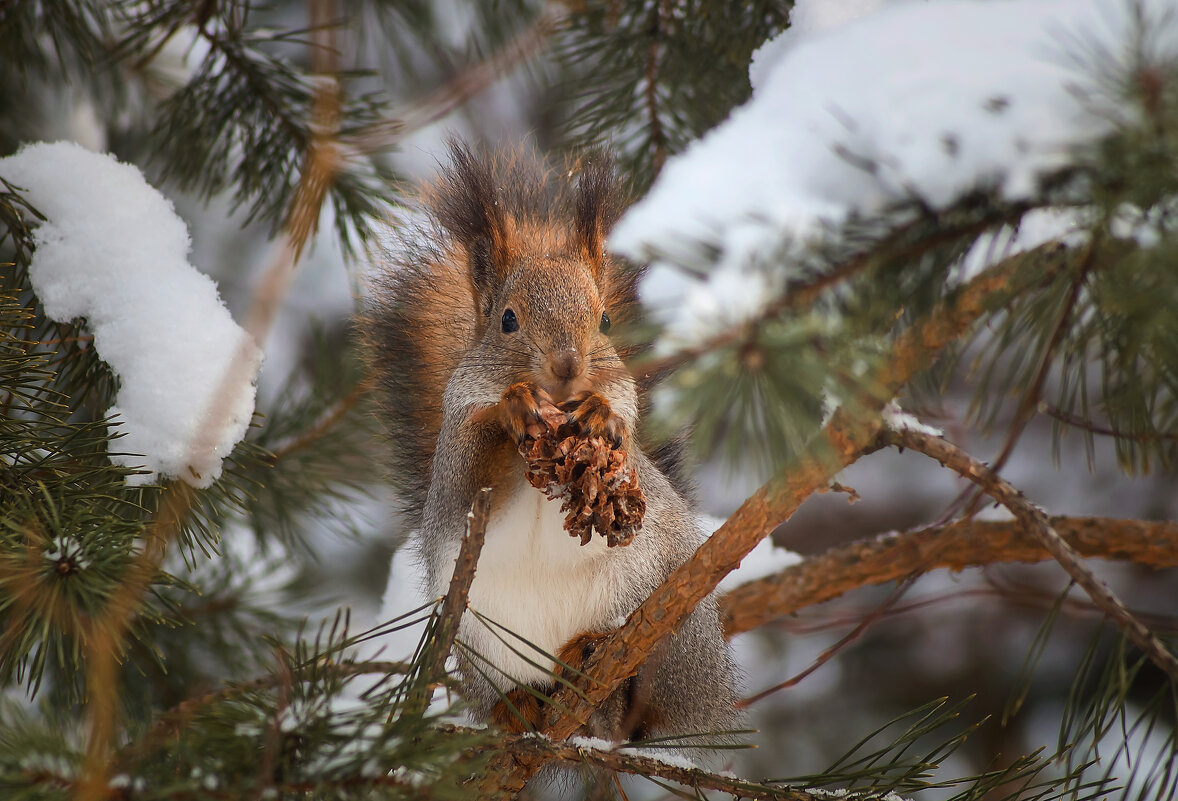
[{"xmin": 610, "ymin": 0, "xmax": 1178, "ymax": 351}]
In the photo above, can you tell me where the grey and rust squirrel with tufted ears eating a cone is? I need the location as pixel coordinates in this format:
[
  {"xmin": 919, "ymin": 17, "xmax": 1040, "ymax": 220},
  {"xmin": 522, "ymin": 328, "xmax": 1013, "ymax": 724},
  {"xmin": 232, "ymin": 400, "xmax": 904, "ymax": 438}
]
[{"xmin": 362, "ymin": 139, "xmax": 740, "ymax": 744}]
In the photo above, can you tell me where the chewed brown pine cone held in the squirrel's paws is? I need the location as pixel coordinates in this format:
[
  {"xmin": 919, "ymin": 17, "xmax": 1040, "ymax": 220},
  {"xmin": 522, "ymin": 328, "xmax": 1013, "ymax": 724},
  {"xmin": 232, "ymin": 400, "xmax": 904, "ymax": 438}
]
[{"xmin": 519, "ymin": 404, "xmax": 647, "ymax": 548}]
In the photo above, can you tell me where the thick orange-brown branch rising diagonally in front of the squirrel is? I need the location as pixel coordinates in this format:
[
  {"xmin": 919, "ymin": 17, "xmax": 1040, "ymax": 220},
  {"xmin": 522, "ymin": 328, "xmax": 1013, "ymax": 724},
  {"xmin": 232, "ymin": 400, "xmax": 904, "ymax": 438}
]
[{"xmin": 481, "ymin": 213, "xmax": 1070, "ymax": 793}]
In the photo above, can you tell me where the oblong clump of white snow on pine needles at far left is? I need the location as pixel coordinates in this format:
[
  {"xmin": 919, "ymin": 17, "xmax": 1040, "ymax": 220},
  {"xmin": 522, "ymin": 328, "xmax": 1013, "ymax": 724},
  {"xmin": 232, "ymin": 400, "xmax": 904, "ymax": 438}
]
[{"xmin": 0, "ymin": 143, "xmax": 262, "ymax": 488}]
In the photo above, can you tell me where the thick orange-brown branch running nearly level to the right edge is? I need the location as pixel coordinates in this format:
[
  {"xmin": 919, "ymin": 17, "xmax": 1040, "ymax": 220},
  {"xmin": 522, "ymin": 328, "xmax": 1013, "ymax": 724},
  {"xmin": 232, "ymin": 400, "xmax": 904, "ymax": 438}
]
[{"xmin": 720, "ymin": 517, "xmax": 1178, "ymax": 637}]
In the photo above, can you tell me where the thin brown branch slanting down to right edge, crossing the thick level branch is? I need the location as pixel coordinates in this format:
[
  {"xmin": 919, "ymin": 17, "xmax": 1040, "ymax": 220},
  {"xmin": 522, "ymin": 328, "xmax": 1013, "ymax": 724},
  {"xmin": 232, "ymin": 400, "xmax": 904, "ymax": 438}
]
[{"xmin": 882, "ymin": 429, "xmax": 1178, "ymax": 681}]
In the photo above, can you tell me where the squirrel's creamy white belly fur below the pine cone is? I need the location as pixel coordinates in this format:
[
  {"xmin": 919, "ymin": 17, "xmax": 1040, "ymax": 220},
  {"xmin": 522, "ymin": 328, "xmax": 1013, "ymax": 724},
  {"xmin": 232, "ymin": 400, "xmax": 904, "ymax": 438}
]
[{"xmin": 459, "ymin": 484, "xmax": 614, "ymax": 690}]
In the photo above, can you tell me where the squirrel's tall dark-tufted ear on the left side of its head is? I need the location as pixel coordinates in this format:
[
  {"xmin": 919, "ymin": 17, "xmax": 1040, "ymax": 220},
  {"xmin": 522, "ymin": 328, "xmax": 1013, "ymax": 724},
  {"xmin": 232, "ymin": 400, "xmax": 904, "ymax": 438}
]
[{"xmin": 431, "ymin": 139, "xmax": 514, "ymax": 315}]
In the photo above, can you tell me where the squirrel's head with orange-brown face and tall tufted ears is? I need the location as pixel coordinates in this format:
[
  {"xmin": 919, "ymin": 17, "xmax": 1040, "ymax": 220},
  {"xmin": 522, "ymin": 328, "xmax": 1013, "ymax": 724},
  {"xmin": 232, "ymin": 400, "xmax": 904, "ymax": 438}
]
[{"xmin": 432, "ymin": 143, "xmax": 633, "ymax": 401}]
